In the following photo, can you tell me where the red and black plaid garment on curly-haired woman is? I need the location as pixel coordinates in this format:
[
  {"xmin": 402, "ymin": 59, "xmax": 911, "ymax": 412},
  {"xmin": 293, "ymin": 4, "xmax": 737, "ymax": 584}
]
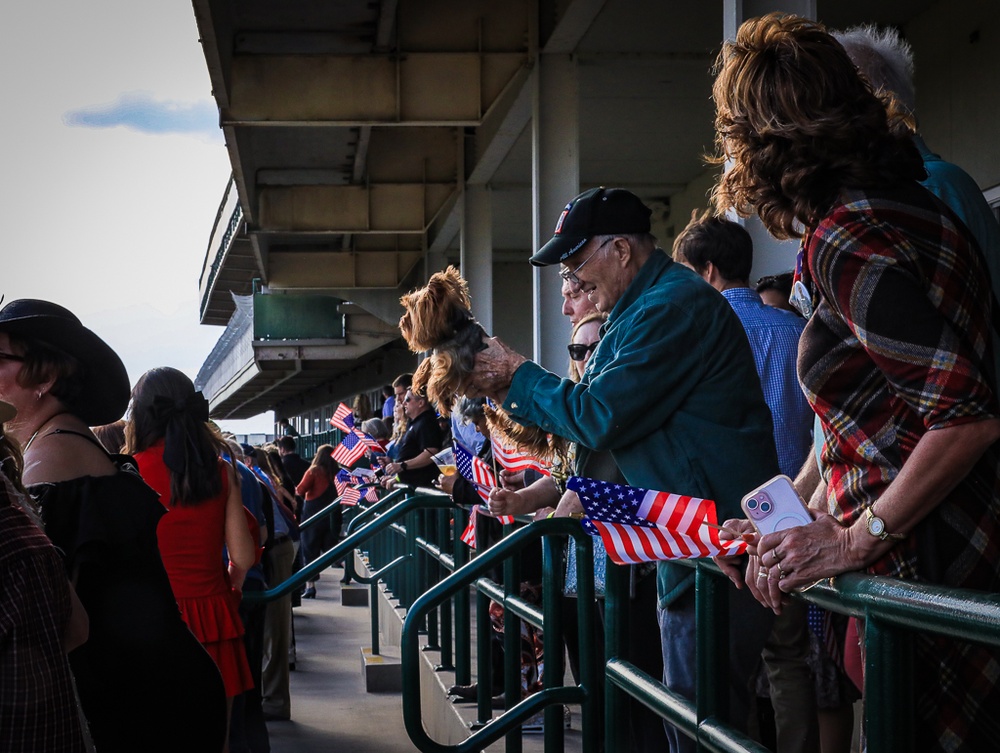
[{"xmin": 799, "ymin": 183, "xmax": 1000, "ymax": 750}]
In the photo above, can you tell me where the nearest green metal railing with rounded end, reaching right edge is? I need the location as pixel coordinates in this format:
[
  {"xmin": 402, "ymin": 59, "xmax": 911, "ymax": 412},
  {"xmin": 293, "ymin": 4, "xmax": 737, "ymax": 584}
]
[{"xmin": 386, "ymin": 482, "xmax": 1000, "ymax": 753}]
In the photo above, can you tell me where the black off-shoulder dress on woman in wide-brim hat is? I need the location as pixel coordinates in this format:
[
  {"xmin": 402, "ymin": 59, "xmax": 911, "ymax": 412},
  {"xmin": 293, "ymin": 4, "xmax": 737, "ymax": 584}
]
[{"xmin": 28, "ymin": 456, "xmax": 226, "ymax": 753}]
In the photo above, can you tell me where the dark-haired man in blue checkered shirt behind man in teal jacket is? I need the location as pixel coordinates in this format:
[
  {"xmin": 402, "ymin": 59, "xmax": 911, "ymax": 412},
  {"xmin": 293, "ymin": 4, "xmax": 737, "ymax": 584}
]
[{"xmin": 673, "ymin": 216, "xmax": 819, "ymax": 753}]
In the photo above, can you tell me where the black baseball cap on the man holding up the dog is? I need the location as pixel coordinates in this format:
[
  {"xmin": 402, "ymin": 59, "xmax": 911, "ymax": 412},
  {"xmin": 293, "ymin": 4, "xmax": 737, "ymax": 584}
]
[{"xmin": 531, "ymin": 186, "xmax": 652, "ymax": 267}]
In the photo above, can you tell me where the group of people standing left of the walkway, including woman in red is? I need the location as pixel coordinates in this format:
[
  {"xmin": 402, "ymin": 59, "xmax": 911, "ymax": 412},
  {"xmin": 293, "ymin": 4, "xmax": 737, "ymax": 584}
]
[{"xmin": 0, "ymin": 299, "xmax": 356, "ymax": 753}]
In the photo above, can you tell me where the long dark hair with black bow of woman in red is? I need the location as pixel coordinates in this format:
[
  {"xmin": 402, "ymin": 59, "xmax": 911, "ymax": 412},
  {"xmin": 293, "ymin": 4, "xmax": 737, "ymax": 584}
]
[{"xmin": 125, "ymin": 366, "xmax": 228, "ymax": 505}]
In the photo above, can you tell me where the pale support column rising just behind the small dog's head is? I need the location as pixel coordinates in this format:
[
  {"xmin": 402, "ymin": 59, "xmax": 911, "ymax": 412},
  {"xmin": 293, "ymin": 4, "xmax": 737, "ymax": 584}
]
[{"xmin": 461, "ymin": 185, "xmax": 493, "ymax": 334}]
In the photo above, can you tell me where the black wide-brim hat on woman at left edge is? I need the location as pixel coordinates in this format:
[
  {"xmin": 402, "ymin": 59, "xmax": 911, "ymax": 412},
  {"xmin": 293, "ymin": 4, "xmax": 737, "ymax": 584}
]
[{"xmin": 0, "ymin": 298, "xmax": 131, "ymax": 426}]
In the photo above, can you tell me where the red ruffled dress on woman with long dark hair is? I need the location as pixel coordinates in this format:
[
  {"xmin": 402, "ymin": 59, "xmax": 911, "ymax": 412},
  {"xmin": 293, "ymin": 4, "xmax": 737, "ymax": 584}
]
[{"xmin": 134, "ymin": 442, "xmax": 253, "ymax": 697}]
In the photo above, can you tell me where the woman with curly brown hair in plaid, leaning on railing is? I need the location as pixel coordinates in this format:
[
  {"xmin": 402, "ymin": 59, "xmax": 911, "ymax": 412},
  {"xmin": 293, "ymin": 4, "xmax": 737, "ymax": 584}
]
[{"xmin": 713, "ymin": 14, "xmax": 1000, "ymax": 750}]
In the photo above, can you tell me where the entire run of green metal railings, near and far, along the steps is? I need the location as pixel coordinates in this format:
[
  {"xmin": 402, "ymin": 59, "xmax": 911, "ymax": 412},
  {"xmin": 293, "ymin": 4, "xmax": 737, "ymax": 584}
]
[{"xmin": 245, "ymin": 487, "xmax": 1000, "ymax": 753}]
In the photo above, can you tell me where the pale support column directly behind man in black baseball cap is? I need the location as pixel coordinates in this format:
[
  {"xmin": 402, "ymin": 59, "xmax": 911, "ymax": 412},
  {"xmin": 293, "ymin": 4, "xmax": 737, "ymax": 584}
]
[{"xmin": 531, "ymin": 54, "xmax": 580, "ymax": 374}]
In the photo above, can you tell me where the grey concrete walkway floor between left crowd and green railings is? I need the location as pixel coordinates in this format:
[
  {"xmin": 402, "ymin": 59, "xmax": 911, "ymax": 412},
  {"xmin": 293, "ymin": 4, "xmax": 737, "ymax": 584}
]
[{"xmin": 267, "ymin": 568, "xmax": 416, "ymax": 753}]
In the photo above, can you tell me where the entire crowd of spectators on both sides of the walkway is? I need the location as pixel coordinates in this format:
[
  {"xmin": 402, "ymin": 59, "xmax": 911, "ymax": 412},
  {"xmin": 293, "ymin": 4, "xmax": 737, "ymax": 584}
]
[{"xmin": 0, "ymin": 14, "xmax": 1000, "ymax": 753}]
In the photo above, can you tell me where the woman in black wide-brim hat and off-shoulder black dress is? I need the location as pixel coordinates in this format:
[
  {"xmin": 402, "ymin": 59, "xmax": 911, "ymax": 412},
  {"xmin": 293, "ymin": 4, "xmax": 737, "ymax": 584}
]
[{"xmin": 0, "ymin": 299, "xmax": 226, "ymax": 753}]
